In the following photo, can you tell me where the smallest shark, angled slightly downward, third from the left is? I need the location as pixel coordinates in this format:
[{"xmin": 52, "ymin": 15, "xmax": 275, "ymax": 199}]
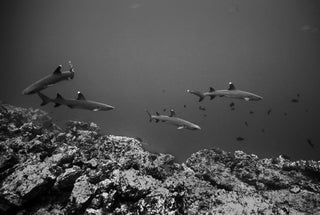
[{"xmin": 146, "ymin": 109, "xmax": 201, "ymax": 130}]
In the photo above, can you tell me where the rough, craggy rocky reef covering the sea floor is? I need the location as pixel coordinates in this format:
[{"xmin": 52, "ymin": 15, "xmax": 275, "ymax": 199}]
[{"xmin": 0, "ymin": 104, "xmax": 320, "ymax": 215}]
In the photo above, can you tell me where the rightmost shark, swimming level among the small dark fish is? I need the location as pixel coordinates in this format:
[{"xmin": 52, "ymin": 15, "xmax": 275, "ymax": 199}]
[{"xmin": 187, "ymin": 82, "xmax": 263, "ymax": 102}]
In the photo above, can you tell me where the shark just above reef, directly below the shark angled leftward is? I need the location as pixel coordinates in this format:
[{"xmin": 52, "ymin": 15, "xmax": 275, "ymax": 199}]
[{"xmin": 37, "ymin": 91, "xmax": 115, "ymax": 111}]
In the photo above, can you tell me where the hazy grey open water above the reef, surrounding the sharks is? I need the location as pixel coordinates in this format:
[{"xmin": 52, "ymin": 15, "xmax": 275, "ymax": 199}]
[{"xmin": 0, "ymin": 0, "xmax": 320, "ymax": 161}]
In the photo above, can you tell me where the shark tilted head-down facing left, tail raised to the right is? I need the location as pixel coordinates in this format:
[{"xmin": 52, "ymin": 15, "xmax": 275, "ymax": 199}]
[{"xmin": 22, "ymin": 61, "xmax": 74, "ymax": 95}]
